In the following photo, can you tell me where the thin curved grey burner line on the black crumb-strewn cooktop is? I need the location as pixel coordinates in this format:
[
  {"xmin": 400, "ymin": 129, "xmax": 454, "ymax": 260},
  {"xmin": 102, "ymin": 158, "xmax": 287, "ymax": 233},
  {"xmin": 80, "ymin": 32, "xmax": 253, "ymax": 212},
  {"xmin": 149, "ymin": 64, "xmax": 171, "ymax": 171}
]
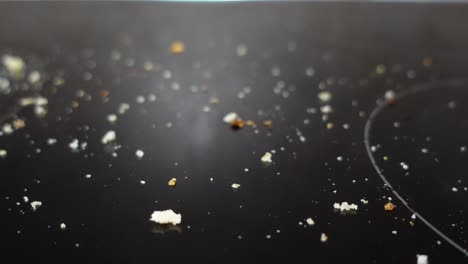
[{"xmin": 364, "ymin": 80, "xmax": 468, "ymax": 257}]
